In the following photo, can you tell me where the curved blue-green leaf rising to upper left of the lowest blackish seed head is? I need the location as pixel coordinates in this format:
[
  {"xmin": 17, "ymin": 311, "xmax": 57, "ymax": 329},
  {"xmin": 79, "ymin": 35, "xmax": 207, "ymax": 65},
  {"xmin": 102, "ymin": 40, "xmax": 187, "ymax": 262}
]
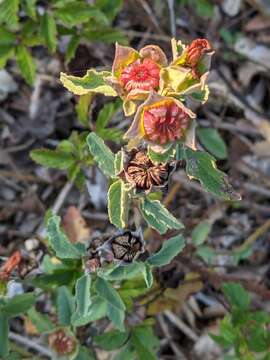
[{"xmin": 46, "ymin": 215, "xmax": 82, "ymax": 259}]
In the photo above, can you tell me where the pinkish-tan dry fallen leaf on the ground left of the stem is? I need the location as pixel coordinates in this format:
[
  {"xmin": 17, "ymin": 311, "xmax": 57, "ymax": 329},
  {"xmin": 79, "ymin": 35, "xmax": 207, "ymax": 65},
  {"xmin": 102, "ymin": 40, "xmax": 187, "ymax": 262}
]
[{"xmin": 63, "ymin": 206, "xmax": 91, "ymax": 243}]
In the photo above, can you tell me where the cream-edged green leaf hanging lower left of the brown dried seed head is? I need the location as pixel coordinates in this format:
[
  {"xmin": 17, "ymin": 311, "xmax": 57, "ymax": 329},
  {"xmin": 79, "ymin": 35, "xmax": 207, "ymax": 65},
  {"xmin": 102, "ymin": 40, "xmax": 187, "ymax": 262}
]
[{"xmin": 108, "ymin": 180, "xmax": 130, "ymax": 229}]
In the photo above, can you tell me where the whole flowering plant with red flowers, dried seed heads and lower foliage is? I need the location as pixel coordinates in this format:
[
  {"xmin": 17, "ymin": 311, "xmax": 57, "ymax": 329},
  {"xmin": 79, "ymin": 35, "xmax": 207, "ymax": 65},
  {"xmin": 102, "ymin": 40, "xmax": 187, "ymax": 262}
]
[{"xmin": 0, "ymin": 39, "xmax": 243, "ymax": 360}]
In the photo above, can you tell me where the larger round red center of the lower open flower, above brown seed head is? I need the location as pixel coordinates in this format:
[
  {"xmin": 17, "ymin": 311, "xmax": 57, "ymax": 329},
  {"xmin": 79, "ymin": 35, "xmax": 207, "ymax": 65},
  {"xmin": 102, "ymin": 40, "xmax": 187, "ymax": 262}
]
[{"xmin": 143, "ymin": 102, "xmax": 189, "ymax": 144}]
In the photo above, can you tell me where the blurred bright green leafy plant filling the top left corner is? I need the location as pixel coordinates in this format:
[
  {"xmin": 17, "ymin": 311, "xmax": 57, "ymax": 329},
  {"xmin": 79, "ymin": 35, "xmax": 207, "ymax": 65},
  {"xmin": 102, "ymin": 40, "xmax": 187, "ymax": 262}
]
[{"xmin": 0, "ymin": 0, "xmax": 126, "ymax": 85}]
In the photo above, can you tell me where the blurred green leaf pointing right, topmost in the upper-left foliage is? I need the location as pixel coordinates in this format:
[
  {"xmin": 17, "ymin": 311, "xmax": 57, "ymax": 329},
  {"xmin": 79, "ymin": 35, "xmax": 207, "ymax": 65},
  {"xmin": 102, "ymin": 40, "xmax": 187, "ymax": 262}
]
[{"xmin": 55, "ymin": 1, "xmax": 109, "ymax": 27}]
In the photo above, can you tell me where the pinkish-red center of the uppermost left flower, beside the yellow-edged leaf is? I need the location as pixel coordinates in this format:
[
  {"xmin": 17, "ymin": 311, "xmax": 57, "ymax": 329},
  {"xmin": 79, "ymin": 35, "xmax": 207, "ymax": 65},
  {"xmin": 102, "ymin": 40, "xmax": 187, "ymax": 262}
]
[{"xmin": 120, "ymin": 59, "xmax": 160, "ymax": 91}]
